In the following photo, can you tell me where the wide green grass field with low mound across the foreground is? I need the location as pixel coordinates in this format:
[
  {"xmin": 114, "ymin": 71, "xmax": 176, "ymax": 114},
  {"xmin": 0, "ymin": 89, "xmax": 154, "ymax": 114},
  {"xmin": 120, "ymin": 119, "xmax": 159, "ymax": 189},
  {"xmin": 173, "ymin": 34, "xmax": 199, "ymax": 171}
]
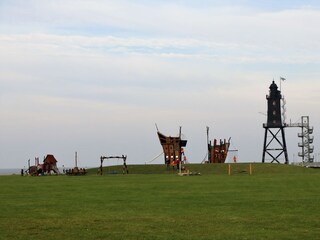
[{"xmin": 0, "ymin": 164, "xmax": 320, "ymax": 240}]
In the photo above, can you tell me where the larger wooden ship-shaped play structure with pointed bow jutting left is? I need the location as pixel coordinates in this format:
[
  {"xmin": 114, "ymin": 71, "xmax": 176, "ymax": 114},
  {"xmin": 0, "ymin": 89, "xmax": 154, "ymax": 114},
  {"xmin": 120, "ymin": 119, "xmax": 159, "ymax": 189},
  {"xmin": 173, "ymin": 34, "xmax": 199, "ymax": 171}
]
[{"xmin": 157, "ymin": 127, "xmax": 187, "ymax": 166}]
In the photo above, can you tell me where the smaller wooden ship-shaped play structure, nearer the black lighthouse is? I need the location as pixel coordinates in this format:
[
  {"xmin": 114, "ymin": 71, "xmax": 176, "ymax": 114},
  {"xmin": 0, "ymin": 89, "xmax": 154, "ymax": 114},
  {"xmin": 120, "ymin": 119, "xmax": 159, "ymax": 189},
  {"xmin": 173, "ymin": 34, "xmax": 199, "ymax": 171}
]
[{"xmin": 207, "ymin": 127, "xmax": 230, "ymax": 163}]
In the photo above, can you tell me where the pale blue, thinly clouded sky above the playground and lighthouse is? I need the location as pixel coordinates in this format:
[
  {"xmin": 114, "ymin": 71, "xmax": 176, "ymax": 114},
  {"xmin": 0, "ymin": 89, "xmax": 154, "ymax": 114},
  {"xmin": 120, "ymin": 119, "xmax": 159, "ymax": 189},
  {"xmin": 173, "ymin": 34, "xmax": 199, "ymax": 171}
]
[{"xmin": 0, "ymin": 0, "xmax": 320, "ymax": 168}]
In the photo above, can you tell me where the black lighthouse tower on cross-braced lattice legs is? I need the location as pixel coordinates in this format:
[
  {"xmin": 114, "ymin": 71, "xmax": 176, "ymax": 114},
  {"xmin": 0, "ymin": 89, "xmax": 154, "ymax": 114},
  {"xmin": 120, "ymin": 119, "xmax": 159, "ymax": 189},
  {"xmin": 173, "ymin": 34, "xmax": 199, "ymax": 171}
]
[{"xmin": 262, "ymin": 81, "xmax": 289, "ymax": 164}]
